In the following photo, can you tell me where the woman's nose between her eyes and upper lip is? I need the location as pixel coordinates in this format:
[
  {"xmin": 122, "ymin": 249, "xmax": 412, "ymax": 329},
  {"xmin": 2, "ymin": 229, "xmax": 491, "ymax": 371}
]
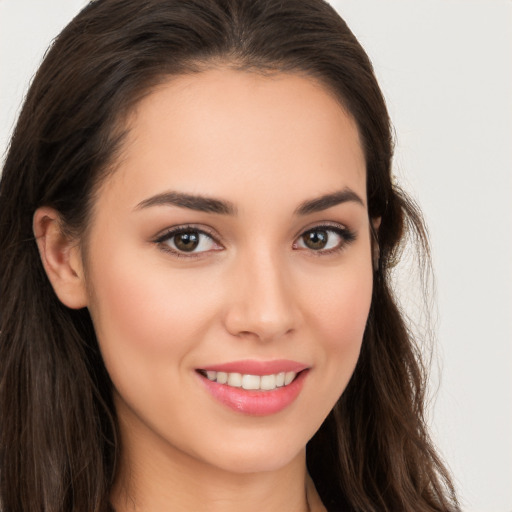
[{"xmin": 225, "ymin": 247, "xmax": 299, "ymax": 341}]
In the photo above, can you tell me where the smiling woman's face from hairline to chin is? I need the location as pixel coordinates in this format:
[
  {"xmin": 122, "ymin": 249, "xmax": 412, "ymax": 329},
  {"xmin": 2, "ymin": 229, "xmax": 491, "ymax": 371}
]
[{"xmin": 85, "ymin": 69, "xmax": 372, "ymax": 472}]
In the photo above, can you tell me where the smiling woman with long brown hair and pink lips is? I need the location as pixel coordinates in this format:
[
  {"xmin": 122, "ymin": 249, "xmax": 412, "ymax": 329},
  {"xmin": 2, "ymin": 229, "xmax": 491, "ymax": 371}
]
[{"xmin": 0, "ymin": 0, "xmax": 458, "ymax": 512}]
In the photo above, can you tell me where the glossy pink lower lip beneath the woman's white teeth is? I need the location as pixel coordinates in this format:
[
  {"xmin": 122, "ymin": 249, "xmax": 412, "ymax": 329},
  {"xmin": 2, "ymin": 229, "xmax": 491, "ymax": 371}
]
[{"xmin": 198, "ymin": 370, "xmax": 308, "ymax": 416}]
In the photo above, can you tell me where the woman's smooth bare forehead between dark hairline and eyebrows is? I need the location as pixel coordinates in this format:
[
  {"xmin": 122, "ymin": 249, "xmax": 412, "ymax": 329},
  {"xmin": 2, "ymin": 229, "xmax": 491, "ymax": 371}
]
[{"xmin": 97, "ymin": 69, "xmax": 366, "ymax": 212}]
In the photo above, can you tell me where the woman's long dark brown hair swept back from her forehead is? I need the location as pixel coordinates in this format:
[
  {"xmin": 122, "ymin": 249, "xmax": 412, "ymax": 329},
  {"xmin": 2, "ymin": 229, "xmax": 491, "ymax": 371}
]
[{"xmin": 0, "ymin": 0, "xmax": 458, "ymax": 512}]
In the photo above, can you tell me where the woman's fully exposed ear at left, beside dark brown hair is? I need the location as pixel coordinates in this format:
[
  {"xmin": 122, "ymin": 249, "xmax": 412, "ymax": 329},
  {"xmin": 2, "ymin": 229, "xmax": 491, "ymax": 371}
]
[{"xmin": 32, "ymin": 207, "xmax": 87, "ymax": 309}]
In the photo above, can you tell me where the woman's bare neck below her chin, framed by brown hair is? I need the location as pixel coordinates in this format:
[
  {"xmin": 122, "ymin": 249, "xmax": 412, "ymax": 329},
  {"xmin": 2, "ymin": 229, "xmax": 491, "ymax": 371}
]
[{"xmin": 112, "ymin": 450, "xmax": 308, "ymax": 512}]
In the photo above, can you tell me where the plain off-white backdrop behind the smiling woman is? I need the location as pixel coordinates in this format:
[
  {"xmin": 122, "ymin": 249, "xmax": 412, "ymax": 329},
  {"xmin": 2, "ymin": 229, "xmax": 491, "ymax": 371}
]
[{"xmin": 0, "ymin": 0, "xmax": 512, "ymax": 512}]
